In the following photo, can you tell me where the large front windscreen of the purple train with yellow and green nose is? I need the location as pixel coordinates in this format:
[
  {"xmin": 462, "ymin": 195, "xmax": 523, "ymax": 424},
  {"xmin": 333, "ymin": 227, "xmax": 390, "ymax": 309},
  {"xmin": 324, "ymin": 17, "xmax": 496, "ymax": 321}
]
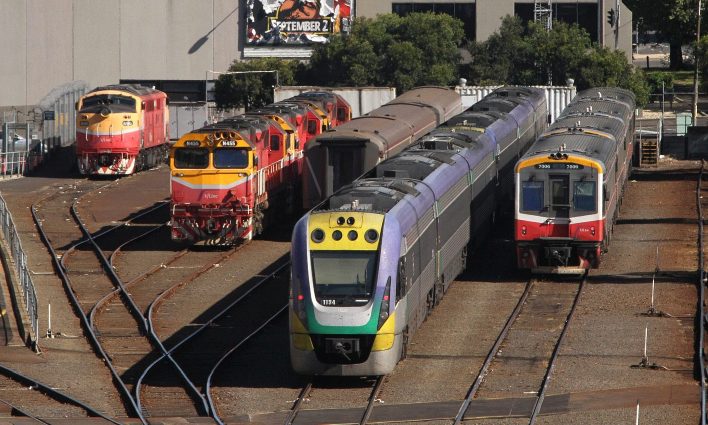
[{"xmin": 310, "ymin": 251, "xmax": 377, "ymax": 306}]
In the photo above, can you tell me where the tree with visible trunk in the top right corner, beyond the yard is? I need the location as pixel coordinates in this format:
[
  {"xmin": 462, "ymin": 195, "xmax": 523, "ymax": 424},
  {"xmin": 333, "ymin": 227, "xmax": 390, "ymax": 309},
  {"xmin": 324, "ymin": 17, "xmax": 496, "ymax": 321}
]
[{"xmin": 624, "ymin": 0, "xmax": 705, "ymax": 69}]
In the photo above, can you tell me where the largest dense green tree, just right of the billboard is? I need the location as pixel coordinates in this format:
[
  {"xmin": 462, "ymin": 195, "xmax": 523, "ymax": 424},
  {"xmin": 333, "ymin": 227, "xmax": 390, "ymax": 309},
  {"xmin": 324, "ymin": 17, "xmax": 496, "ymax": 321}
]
[{"xmin": 306, "ymin": 13, "xmax": 464, "ymax": 92}]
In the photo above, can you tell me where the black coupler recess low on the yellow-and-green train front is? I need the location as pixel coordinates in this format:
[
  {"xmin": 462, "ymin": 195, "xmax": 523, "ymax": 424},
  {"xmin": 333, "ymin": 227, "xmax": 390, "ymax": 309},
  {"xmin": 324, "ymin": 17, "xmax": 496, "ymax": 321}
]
[{"xmin": 311, "ymin": 335, "xmax": 376, "ymax": 364}]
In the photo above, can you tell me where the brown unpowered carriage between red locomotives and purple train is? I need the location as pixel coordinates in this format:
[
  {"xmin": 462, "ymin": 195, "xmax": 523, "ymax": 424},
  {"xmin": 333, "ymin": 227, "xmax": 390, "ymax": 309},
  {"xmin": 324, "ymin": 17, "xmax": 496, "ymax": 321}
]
[{"xmin": 302, "ymin": 86, "xmax": 462, "ymax": 210}]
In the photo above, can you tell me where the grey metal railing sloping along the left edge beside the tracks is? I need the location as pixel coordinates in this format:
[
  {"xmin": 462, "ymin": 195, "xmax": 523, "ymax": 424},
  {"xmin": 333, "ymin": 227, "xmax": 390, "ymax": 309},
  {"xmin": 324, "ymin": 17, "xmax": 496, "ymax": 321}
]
[{"xmin": 0, "ymin": 195, "xmax": 39, "ymax": 350}]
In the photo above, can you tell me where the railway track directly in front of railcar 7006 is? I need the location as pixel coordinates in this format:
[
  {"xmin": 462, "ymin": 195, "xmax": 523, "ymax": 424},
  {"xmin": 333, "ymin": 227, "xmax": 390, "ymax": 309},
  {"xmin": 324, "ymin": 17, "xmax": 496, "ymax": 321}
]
[{"xmin": 454, "ymin": 273, "xmax": 587, "ymax": 425}]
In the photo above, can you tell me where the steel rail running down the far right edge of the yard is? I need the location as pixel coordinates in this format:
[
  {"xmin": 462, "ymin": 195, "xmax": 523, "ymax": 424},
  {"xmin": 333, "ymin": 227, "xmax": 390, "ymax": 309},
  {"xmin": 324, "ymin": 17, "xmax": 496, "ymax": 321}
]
[{"xmin": 696, "ymin": 160, "xmax": 707, "ymax": 425}]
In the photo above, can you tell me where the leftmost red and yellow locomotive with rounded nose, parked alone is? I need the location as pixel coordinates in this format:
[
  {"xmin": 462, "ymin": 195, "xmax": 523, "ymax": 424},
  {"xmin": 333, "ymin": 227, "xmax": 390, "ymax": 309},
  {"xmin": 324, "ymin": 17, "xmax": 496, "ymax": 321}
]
[{"xmin": 76, "ymin": 84, "xmax": 170, "ymax": 175}]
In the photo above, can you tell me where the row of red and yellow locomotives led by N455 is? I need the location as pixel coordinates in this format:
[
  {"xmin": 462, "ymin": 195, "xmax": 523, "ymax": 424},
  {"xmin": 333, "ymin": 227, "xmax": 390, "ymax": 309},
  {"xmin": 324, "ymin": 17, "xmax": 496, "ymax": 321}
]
[{"xmin": 170, "ymin": 92, "xmax": 351, "ymax": 245}]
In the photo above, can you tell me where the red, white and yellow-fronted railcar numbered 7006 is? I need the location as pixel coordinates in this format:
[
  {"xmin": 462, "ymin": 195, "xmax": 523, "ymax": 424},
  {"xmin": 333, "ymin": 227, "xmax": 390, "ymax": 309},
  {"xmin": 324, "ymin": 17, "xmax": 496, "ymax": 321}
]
[{"xmin": 514, "ymin": 87, "xmax": 636, "ymax": 275}]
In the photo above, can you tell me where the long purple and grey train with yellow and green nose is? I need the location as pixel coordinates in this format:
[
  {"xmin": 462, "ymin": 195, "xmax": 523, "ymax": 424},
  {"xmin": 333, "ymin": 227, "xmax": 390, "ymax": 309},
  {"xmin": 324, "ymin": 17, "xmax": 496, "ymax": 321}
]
[{"xmin": 290, "ymin": 87, "xmax": 547, "ymax": 375}]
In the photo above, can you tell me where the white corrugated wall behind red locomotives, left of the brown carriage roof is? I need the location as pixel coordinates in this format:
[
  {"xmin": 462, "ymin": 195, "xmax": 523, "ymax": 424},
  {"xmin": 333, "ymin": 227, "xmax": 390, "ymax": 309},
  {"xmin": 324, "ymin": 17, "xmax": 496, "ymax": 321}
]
[{"xmin": 274, "ymin": 86, "xmax": 396, "ymax": 118}]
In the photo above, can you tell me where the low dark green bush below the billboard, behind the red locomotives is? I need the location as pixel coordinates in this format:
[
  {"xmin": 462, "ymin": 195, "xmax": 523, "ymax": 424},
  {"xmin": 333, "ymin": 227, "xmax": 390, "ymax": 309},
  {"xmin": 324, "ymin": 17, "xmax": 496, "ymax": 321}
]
[{"xmin": 215, "ymin": 58, "xmax": 298, "ymax": 109}]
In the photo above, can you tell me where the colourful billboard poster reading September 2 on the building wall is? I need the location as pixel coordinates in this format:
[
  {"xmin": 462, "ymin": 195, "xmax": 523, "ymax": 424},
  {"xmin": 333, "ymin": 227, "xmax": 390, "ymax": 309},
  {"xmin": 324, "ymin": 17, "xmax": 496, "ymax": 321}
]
[{"xmin": 246, "ymin": 0, "xmax": 353, "ymax": 46}]
